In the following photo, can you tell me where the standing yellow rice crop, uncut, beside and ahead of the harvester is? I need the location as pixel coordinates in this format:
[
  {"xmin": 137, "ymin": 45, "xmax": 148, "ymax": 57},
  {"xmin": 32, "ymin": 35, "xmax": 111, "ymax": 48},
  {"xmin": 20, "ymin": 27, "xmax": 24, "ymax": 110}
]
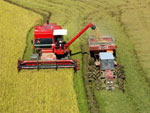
[{"xmin": 0, "ymin": 1, "xmax": 79, "ymax": 113}]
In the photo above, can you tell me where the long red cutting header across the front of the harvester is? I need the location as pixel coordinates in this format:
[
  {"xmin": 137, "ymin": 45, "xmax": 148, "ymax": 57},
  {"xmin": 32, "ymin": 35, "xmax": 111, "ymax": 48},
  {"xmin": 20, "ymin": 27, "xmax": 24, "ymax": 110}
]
[{"xmin": 17, "ymin": 60, "xmax": 79, "ymax": 72}]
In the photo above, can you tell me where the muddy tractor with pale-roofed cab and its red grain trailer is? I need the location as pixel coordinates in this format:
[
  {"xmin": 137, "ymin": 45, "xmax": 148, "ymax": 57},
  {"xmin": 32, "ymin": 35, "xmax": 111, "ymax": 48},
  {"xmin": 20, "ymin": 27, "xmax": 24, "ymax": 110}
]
[{"xmin": 88, "ymin": 36, "xmax": 117, "ymax": 90}]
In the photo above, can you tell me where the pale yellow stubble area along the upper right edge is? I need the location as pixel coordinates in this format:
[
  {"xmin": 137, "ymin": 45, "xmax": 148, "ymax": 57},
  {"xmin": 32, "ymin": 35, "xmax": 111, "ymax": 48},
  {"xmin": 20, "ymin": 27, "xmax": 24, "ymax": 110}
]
[{"xmin": 122, "ymin": 0, "xmax": 150, "ymax": 82}]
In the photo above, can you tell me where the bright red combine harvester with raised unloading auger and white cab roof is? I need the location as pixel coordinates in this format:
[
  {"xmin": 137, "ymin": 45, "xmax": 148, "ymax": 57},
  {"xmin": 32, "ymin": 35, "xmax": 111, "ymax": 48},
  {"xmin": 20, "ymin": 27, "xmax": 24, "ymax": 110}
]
[{"xmin": 17, "ymin": 23, "xmax": 96, "ymax": 71}]
